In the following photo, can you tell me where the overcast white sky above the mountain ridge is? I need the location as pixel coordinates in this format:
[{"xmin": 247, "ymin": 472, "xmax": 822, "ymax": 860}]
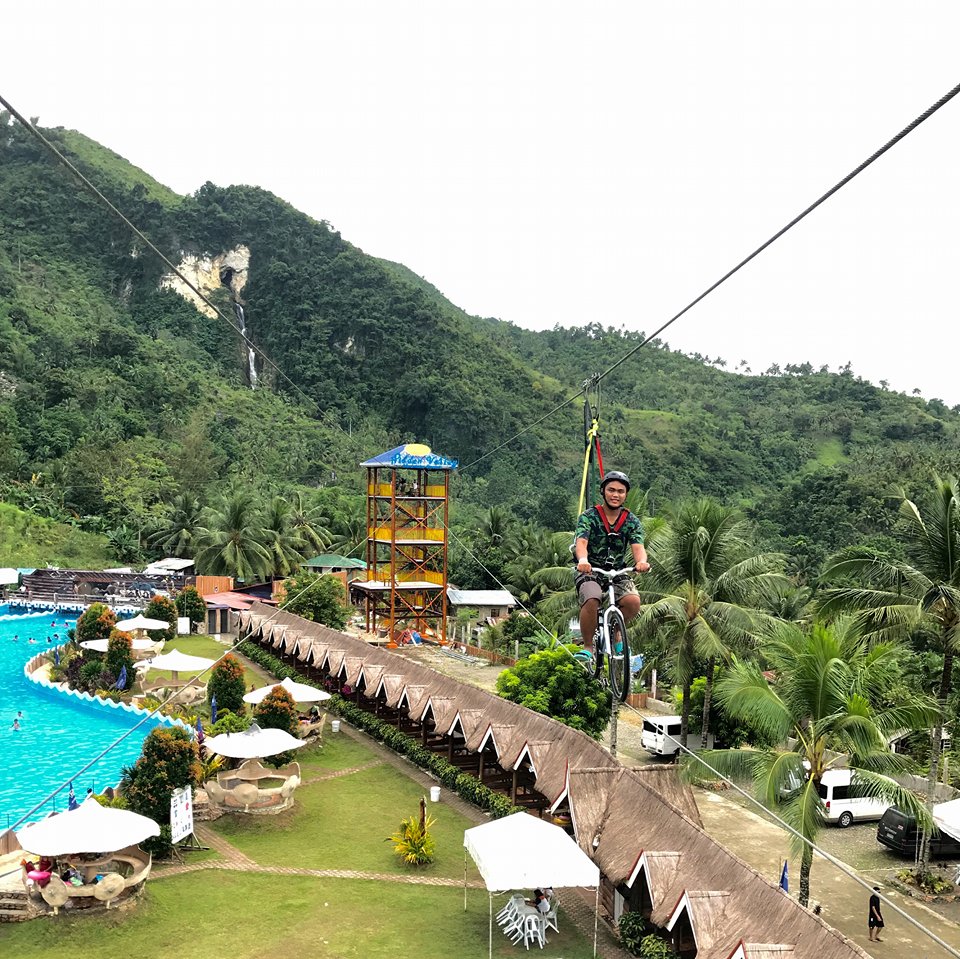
[{"xmin": 7, "ymin": 0, "xmax": 960, "ymax": 405}]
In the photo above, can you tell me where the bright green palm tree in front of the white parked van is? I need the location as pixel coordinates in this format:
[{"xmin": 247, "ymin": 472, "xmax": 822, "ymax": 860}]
[{"xmin": 689, "ymin": 618, "xmax": 936, "ymax": 905}]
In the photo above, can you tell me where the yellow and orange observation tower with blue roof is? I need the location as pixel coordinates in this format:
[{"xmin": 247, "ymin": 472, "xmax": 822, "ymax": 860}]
[{"xmin": 353, "ymin": 443, "xmax": 457, "ymax": 645}]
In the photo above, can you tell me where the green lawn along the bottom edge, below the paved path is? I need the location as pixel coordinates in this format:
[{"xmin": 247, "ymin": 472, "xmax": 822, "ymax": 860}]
[{"xmin": 0, "ymin": 871, "xmax": 593, "ymax": 959}]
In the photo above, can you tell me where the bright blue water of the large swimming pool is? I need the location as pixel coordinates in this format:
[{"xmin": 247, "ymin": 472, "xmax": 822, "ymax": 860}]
[{"xmin": 0, "ymin": 604, "xmax": 169, "ymax": 831}]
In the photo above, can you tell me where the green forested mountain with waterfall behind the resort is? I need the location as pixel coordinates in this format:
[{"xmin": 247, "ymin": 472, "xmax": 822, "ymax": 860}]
[{"xmin": 0, "ymin": 117, "xmax": 960, "ymax": 570}]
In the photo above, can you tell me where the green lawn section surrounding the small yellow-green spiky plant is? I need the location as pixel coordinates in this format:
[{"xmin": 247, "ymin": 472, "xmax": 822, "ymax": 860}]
[{"xmin": 210, "ymin": 766, "xmax": 479, "ymax": 880}]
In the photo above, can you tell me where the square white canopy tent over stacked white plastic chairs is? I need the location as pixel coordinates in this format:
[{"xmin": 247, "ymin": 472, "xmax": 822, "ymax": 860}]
[{"xmin": 463, "ymin": 813, "xmax": 600, "ymax": 956}]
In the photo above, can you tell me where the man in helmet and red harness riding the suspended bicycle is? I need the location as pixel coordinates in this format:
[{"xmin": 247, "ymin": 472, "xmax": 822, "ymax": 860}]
[{"xmin": 573, "ymin": 470, "xmax": 650, "ymax": 653}]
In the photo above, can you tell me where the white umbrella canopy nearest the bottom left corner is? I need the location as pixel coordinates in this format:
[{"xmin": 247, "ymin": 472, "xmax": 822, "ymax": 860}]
[{"xmin": 16, "ymin": 796, "xmax": 160, "ymax": 856}]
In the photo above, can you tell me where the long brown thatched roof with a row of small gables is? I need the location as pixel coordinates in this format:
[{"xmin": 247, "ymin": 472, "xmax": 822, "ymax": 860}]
[{"xmin": 240, "ymin": 604, "xmax": 866, "ymax": 959}]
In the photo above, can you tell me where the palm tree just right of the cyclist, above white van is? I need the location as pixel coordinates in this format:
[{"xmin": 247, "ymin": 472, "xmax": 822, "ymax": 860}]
[{"xmin": 637, "ymin": 498, "xmax": 788, "ymax": 748}]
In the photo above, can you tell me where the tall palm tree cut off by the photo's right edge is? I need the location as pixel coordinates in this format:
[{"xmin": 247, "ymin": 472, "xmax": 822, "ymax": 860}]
[{"xmin": 822, "ymin": 474, "xmax": 960, "ymax": 871}]
